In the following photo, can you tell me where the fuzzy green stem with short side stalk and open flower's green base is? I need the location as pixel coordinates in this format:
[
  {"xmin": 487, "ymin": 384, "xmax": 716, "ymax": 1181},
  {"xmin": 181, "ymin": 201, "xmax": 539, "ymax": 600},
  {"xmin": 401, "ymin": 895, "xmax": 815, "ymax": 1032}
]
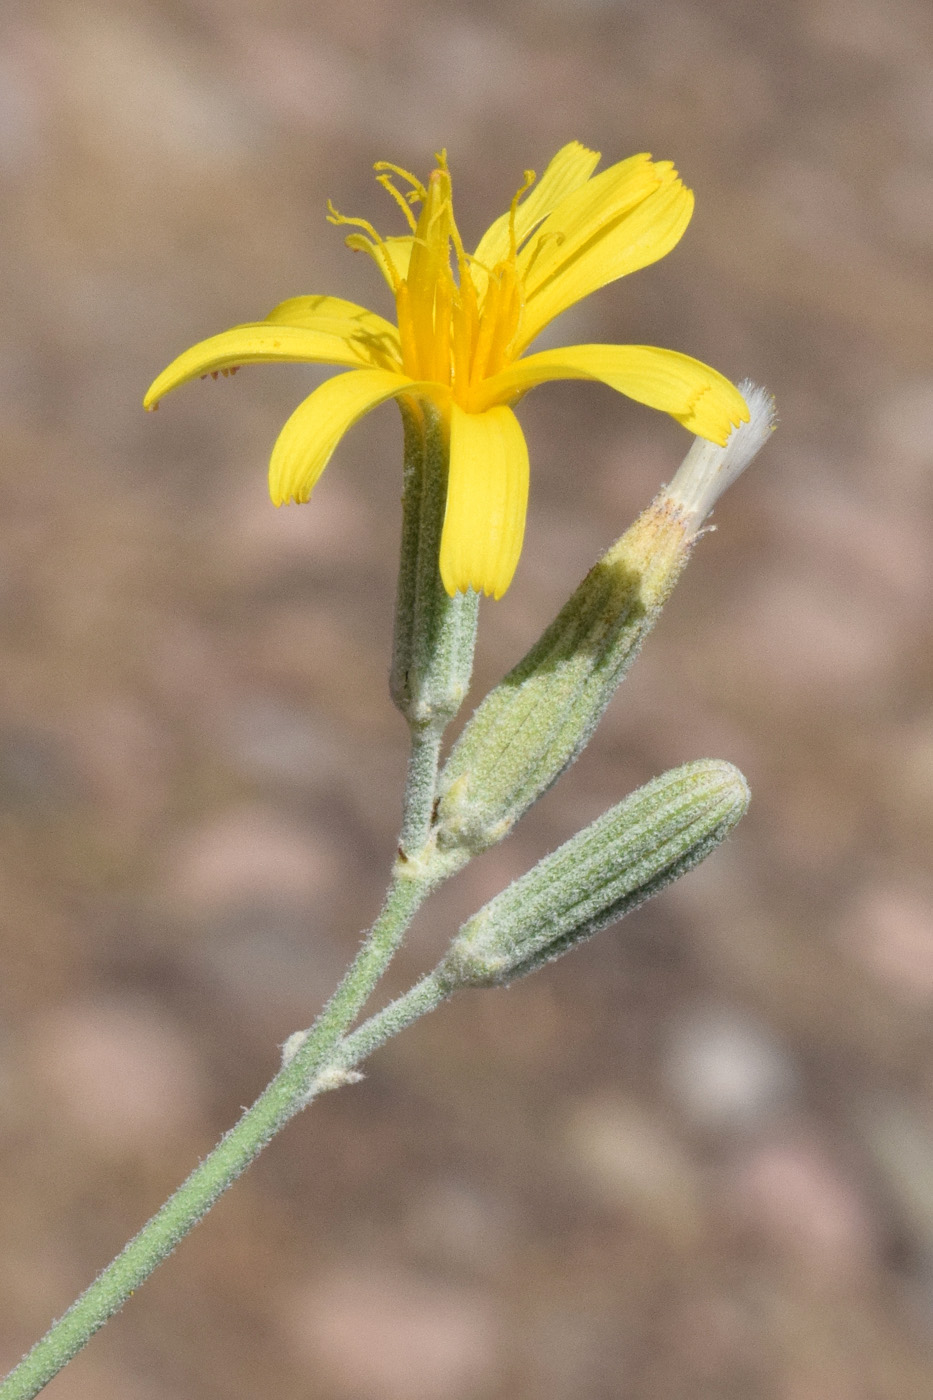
[{"xmin": 0, "ymin": 403, "xmax": 479, "ymax": 1400}]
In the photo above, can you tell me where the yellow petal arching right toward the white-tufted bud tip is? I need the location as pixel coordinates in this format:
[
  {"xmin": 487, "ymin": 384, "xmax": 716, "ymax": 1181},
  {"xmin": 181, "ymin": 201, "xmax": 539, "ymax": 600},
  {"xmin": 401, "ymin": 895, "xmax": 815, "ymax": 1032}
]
[{"xmin": 479, "ymin": 346, "xmax": 748, "ymax": 447}]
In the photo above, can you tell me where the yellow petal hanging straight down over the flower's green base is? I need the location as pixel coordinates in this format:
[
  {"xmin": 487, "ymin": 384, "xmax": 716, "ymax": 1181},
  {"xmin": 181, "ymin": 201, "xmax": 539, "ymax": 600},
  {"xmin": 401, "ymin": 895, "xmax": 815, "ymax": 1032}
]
[{"xmin": 440, "ymin": 403, "xmax": 528, "ymax": 598}]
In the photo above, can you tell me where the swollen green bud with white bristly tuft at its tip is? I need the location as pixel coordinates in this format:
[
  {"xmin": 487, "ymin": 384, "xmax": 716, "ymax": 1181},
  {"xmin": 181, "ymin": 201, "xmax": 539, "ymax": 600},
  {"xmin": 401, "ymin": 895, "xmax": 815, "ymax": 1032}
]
[{"xmin": 437, "ymin": 382, "xmax": 773, "ymax": 853}]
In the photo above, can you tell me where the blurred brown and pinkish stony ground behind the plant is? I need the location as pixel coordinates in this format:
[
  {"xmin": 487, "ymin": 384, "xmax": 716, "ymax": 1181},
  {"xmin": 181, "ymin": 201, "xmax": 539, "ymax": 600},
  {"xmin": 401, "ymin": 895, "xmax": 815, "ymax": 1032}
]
[{"xmin": 0, "ymin": 0, "xmax": 933, "ymax": 1400}]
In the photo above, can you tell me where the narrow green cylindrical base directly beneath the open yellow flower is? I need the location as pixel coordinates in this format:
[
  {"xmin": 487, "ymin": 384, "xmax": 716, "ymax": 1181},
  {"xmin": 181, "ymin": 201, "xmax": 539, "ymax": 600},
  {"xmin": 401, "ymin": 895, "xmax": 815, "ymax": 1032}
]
[{"xmin": 389, "ymin": 403, "xmax": 479, "ymax": 728}]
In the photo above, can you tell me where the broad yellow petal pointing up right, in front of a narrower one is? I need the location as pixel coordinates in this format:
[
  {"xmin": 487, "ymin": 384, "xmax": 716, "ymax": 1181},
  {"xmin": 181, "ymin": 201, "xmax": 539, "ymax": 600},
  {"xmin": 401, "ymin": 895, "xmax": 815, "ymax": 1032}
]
[{"xmin": 514, "ymin": 157, "xmax": 693, "ymax": 351}]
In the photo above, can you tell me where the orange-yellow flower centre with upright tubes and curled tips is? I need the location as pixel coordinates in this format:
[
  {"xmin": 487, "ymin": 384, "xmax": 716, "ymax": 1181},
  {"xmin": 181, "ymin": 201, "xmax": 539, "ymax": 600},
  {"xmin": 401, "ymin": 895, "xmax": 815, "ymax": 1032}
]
[{"xmin": 329, "ymin": 151, "xmax": 534, "ymax": 410}]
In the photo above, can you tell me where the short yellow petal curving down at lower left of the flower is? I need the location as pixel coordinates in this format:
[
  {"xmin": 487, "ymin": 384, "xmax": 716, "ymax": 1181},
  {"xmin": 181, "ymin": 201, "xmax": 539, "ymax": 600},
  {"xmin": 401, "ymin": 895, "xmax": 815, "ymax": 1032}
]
[{"xmin": 269, "ymin": 370, "xmax": 437, "ymax": 505}]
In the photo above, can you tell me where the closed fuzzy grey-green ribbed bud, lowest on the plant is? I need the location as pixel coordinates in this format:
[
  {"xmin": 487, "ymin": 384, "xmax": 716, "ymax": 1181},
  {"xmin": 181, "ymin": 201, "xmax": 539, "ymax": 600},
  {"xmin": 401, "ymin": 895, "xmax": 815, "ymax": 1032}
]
[{"xmin": 438, "ymin": 759, "xmax": 749, "ymax": 987}]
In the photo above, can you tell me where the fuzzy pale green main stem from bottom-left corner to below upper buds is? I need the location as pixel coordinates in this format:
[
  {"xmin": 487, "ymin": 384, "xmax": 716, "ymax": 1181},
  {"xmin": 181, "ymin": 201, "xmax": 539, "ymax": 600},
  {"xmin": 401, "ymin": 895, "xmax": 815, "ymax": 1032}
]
[{"xmin": 0, "ymin": 865, "xmax": 438, "ymax": 1400}]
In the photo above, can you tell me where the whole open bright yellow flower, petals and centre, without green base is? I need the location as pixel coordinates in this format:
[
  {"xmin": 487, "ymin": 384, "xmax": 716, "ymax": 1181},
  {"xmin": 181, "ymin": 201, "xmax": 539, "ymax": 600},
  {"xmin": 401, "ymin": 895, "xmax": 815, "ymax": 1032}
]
[{"xmin": 144, "ymin": 141, "xmax": 748, "ymax": 598}]
